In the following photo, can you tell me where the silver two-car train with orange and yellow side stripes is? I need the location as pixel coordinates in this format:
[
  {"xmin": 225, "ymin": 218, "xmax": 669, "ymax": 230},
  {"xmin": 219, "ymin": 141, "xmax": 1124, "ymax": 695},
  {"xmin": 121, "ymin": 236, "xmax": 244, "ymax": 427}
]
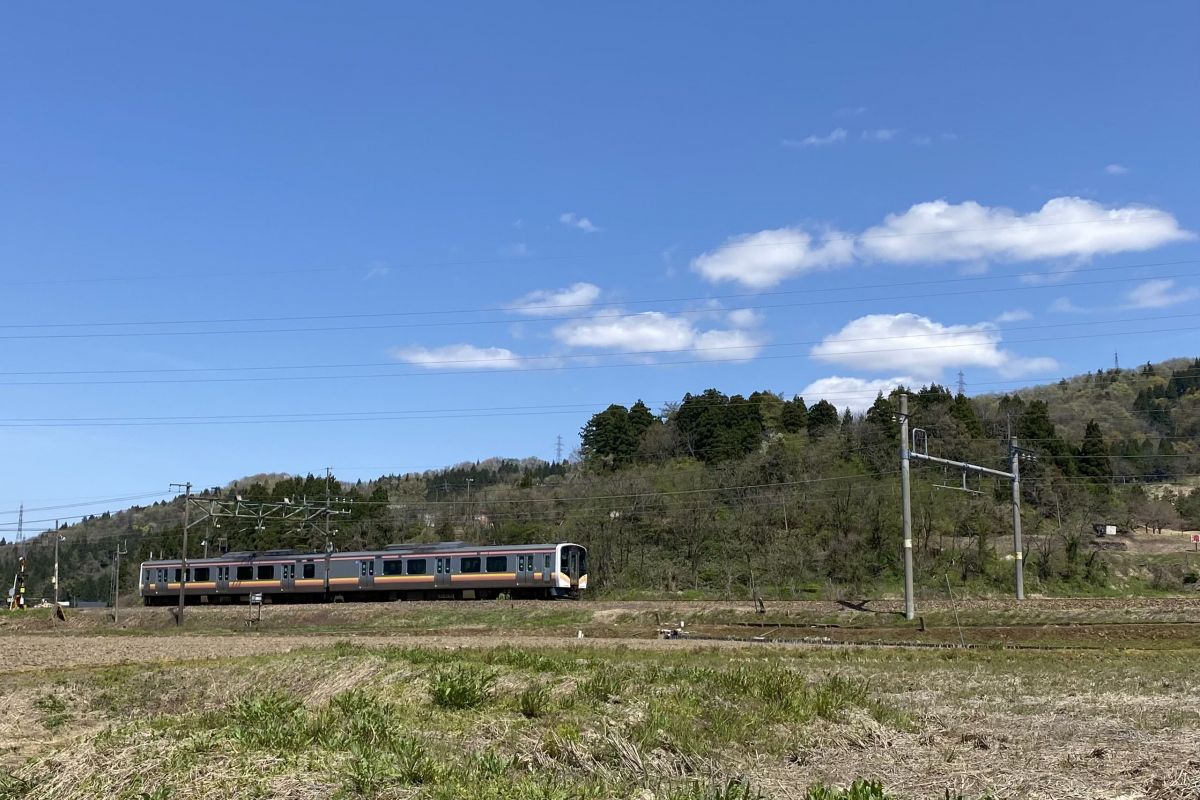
[{"xmin": 139, "ymin": 542, "xmax": 588, "ymax": 606}]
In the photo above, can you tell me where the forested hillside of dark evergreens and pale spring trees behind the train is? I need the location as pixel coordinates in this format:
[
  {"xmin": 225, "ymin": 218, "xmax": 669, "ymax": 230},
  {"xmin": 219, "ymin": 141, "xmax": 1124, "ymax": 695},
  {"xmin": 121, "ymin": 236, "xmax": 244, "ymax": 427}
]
[{"xmin": 0, "ymin": 359, "xmax": 1200, "ymax": 601}]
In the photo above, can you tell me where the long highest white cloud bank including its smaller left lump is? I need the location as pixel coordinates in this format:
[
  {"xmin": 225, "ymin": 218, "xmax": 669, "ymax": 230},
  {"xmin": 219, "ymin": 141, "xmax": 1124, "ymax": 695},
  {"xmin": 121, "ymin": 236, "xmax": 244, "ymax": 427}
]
[{"xmin": 691, "ymin": 197, "xmax": 1195, "ymax": 289}]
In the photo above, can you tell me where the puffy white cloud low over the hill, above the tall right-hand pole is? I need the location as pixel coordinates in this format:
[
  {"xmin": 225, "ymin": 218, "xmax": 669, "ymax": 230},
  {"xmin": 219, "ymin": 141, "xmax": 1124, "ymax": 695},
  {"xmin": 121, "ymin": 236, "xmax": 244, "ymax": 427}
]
[{"xmin": 811, "ymin": 314, "xmax": 1054, "ymax": 379}]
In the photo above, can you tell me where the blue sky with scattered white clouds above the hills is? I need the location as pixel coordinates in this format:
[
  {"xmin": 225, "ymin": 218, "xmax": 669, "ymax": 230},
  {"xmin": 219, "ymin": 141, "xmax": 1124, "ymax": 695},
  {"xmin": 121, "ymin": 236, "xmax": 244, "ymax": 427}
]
[{"xmin": 0, "ymin": 2, "xmax": 1200, "ymax": 527}]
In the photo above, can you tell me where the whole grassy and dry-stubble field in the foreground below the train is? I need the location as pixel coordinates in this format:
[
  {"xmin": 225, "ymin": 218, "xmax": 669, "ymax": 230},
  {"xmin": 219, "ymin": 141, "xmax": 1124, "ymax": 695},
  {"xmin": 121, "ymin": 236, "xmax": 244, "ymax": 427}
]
[{"xmin": 0, "ymin": 601, "xmax": 1200, "ymax": 800}]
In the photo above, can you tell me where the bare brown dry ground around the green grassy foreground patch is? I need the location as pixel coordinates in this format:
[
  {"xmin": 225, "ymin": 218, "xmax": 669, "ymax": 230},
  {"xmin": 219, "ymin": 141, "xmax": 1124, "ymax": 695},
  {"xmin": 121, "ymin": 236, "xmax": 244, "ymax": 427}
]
[{"xmin": 0, "ymin": 597, "xmax": 1200, "ymax": 800}]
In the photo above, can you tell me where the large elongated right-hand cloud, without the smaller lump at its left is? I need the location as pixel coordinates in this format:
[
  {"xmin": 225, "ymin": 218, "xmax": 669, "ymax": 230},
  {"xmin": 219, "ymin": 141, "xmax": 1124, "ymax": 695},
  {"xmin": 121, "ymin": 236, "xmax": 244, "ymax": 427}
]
[{"xmin": 859, "ymin": 197, "xmax": 1194, "ymax": 263}]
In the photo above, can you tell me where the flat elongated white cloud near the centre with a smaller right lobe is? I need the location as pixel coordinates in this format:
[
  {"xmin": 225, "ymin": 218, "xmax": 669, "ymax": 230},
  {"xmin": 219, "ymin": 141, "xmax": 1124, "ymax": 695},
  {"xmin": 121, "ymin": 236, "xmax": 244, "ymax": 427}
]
[{"xmin": 554, "ymin": 311, "xmax": 762, "ymax": 361}]
